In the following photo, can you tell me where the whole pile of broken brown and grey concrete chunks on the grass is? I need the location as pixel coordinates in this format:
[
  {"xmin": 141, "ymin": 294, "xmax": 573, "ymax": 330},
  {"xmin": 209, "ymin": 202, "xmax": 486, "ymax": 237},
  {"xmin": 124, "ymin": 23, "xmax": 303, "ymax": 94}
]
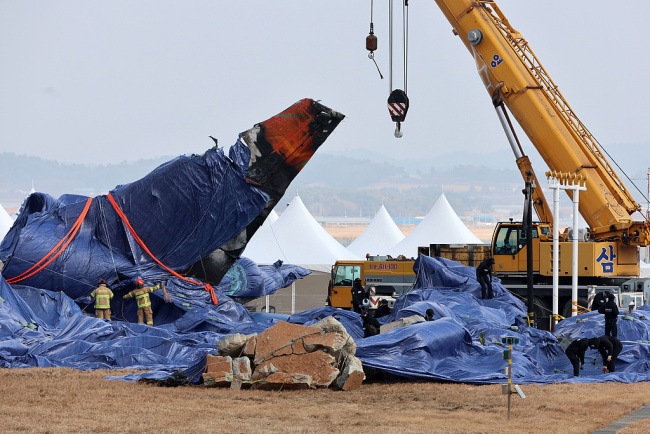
[{"xmin": 203, "ymin": 317, "xmax": 365, "ymax": 390}]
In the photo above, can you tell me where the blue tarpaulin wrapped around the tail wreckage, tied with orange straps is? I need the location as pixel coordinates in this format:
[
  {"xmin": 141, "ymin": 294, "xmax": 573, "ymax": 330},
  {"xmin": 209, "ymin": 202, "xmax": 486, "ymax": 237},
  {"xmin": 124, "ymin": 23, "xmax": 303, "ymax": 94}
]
[{"xmin": 0, "ymin": 141, "xmax": 268, "ymax": 299}]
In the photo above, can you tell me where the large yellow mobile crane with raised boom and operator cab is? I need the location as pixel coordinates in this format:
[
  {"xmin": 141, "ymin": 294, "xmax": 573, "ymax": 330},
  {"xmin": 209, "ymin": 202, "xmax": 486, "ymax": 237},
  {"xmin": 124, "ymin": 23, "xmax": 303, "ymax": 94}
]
[{"xmin": 400, "ymin": 0, "xmax": 650, "ymax": 324}]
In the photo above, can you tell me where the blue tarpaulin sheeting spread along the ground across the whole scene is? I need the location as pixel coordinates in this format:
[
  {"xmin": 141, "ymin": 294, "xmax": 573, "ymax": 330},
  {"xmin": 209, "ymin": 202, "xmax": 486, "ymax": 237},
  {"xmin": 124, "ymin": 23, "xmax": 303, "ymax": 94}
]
[{"xmin": 0, "ymin": 253, "xmax": 650, "ymax": 384}]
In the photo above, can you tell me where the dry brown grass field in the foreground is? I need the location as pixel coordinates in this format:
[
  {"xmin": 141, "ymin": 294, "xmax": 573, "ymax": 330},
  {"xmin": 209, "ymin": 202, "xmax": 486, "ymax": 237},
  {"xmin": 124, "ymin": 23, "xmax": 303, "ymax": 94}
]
[{"xmin": 0, "ymin": 368, "xmax": 650, "ymax": 433}]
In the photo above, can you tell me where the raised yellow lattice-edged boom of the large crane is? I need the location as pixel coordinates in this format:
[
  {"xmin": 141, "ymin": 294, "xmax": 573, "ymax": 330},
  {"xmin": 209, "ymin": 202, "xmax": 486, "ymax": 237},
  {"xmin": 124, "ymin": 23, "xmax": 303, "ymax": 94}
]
[{"xmin": 436, "ymin": 0, "xmax": 650, "ymax": 246}]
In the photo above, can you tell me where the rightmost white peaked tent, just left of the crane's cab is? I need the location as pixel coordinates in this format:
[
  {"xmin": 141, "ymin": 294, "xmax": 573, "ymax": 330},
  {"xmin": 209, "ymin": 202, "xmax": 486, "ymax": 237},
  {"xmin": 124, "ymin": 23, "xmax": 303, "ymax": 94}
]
[{"xmin": 388, "ymin": 193, "xmax": 483, "ymax": 257}]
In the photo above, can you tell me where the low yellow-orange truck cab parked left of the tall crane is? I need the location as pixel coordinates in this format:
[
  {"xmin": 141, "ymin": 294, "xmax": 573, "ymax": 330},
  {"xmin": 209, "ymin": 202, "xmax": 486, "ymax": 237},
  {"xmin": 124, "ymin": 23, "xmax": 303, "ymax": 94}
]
[{"xmin": 327, "ymin": 256, "xmax": 415, "ymax": 310}]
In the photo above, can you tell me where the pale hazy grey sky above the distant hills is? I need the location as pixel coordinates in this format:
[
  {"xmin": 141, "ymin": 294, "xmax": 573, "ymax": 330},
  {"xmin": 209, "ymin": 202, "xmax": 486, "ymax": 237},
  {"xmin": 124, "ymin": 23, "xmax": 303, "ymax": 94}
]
[{"xmin": 0, "ymin": 0, "xmax": 650, "ymax": 167}]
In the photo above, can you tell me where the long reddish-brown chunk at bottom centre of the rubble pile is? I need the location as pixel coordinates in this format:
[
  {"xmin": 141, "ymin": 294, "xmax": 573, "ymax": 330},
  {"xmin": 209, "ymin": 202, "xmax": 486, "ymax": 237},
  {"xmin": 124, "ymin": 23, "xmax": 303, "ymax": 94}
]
[{"xmin": 253, "ymin": 351, "xmax": 340, "ymax": 387}]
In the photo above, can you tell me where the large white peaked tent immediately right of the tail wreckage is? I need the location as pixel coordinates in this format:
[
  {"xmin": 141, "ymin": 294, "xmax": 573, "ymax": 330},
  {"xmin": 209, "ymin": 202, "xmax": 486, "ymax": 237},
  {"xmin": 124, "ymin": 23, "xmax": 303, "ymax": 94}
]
[{"xmin": 242, "ymin": 195, "xmax": 360, "ymax": 272}]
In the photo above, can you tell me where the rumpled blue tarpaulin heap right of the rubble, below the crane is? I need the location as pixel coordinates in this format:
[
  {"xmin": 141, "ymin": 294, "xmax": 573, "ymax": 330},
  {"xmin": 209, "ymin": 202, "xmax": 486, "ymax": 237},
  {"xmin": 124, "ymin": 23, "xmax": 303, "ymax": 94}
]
[{"xmin": 357, "ymin": 256, "xmax": 650, "ymax": 384}]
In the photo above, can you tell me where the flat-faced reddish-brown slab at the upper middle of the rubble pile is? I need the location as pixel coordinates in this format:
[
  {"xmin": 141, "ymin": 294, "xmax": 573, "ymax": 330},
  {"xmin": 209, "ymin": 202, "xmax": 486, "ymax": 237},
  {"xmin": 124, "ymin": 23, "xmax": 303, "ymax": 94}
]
[{"xmin": 254, "ymin": 321, "xmax": 321, "ymax": 365}]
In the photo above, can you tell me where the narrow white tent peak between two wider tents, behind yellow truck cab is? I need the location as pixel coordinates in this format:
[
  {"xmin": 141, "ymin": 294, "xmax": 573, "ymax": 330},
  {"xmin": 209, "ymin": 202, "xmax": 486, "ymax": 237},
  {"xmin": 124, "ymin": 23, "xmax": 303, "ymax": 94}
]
[{"xmin": 348, "ymin": 204, "xmax": 404, "ymax": 258}]
